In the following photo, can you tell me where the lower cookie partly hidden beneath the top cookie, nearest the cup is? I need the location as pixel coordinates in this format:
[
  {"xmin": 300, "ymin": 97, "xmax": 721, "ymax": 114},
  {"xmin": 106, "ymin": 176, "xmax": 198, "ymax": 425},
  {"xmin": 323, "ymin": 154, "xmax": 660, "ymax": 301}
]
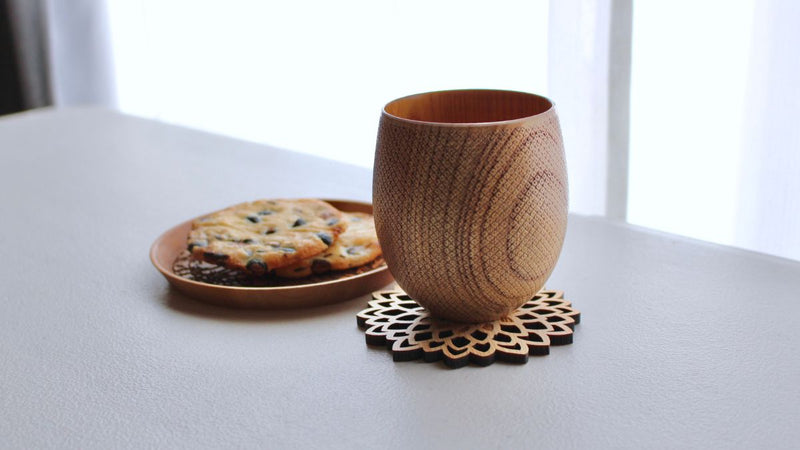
[{"xmin": 275, "ymin": 213, "xmax": 381, "ymax": 278}]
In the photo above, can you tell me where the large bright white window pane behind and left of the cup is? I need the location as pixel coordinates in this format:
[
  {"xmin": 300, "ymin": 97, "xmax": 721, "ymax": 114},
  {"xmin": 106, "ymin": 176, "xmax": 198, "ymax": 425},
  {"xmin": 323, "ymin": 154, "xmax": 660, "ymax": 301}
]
[{"xmin": 109, "ymin": 0, "xmax": 548, "ymax": 167}]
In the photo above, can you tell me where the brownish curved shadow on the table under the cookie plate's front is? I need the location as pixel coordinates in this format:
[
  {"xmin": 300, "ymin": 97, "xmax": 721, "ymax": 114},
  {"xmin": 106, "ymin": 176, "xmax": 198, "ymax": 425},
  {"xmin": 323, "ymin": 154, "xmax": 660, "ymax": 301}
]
[{"xmin": 161, "ymin": 286, "xmax": 370, "ymax": 322}]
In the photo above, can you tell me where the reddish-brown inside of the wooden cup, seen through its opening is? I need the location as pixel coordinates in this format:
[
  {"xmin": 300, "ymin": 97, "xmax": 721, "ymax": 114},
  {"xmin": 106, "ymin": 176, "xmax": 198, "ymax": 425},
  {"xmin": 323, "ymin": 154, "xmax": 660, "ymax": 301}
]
[{"xmin": 384, "ymin": 89, "xmax": 553, "ymax": 124}]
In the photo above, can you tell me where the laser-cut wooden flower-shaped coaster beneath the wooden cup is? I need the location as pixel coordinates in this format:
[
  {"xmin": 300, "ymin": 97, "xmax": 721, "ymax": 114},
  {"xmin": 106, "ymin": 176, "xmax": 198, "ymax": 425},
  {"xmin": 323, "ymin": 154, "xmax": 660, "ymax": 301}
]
[{"xmin": 356, "ymin": 290, "xmax": 581, "ymax": 368}]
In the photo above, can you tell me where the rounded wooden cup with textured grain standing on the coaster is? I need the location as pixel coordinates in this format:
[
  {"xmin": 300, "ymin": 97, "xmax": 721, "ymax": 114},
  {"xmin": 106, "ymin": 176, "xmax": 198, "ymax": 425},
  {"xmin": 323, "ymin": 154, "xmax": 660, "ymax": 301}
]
[{"xmin": 372, "ymin": 90, "xmax": 567, "ymax": 323}]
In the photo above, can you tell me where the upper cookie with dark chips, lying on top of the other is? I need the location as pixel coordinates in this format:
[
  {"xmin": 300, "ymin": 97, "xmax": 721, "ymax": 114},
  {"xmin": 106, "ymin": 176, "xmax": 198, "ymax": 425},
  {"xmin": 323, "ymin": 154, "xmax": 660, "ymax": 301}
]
[{"xmin": 188, "ymin": 199, "xmax": 347, "ymax": 275}]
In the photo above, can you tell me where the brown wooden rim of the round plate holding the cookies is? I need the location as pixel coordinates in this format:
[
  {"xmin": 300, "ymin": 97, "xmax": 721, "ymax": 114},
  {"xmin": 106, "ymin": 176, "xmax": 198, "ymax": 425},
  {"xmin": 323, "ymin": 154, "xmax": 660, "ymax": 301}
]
[{"xmin": 150, "ymin": 200, "xmax": 392, "ymax": 309}]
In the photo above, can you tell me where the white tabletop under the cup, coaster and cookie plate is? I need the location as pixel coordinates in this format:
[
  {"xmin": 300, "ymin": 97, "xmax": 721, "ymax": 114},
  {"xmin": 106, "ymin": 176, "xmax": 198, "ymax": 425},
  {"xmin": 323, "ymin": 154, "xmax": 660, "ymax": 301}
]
[{"xmin": 0, "ymin": 109, "xmax": 800, "ymax": 448}]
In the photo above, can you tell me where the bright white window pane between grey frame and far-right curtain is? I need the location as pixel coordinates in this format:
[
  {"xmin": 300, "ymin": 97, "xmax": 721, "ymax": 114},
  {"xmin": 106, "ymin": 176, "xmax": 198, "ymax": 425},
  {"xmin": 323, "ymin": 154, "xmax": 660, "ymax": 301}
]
[{"xmin": 628, "ymin": 0, "xmax": 755, "ymax": 244}]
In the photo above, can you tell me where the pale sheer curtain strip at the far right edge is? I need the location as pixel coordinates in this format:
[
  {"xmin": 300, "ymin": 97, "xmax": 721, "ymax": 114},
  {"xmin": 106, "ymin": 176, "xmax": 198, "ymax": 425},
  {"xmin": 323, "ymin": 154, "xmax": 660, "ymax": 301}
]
[{"xmin": 734, "ymin": 0, "xmax": 800, "ymax": 259}]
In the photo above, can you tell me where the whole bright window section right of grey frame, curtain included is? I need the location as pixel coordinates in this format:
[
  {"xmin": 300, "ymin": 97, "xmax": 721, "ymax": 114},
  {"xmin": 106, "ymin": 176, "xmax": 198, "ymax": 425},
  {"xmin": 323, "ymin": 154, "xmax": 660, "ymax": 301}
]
[{"xmin": 628, "ymin": 0, "xmax": 800, "ymax": 259}]
